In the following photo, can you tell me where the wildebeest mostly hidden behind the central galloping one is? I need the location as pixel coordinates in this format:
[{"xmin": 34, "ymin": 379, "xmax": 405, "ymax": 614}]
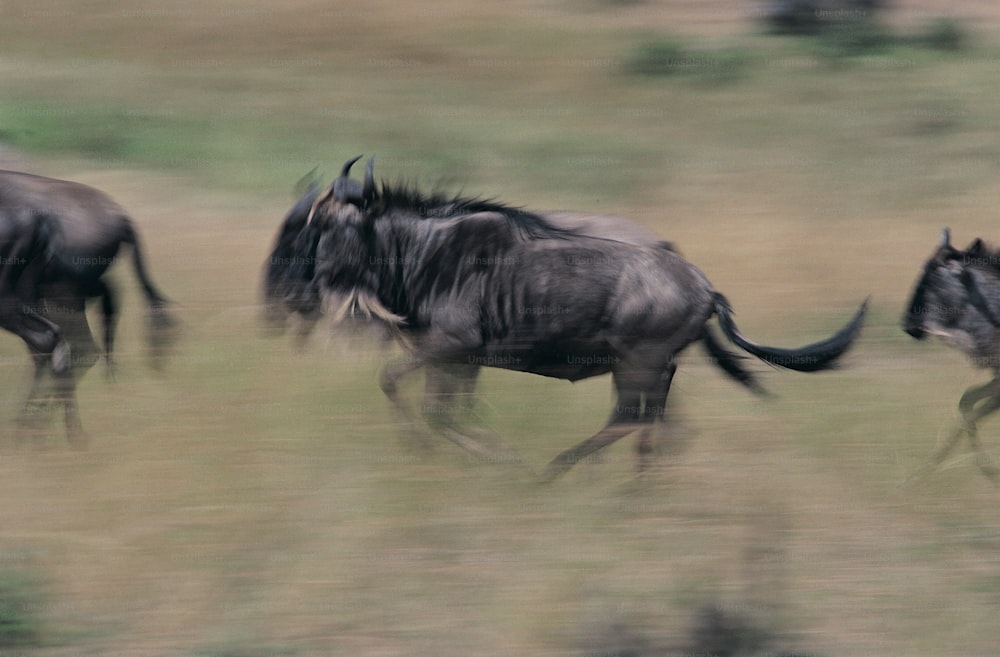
[{"xmin": 263, "ymin": 158, "xmax": 688, "ymax": 459}]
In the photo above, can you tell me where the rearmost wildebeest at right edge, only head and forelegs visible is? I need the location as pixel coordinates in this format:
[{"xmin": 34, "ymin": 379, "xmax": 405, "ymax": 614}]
[{"xmin": 903, "ymin": 228, "xmax": 1000, "ymax": 483}]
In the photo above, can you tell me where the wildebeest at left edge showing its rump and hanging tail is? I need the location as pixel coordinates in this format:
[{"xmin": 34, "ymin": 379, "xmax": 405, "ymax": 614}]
[{"xmin": 0, "ymin": 171, "xmax": 175, "ymax": 447}]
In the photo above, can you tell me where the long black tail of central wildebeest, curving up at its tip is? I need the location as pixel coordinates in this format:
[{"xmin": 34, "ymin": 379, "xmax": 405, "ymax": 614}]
[{"xmin": 715, "ymin": 293, "xmax": 868, "ymax": 372}]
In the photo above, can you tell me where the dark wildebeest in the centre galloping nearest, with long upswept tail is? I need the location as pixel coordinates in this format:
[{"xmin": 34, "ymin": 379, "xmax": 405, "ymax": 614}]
[{"xmin": 274, "ymin": 156, "xmax": 865, "ymax": 479}]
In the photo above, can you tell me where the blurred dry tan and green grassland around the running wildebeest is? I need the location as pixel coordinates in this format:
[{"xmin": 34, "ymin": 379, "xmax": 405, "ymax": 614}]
[{"xmin": 0, "ymin": 0, "xmax": 1000, "ymax": 657}]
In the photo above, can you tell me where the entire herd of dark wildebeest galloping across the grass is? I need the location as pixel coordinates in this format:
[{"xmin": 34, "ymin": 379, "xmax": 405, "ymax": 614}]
[{"xmin": 0, "ymin": 157, "xmax": 1000, "ymax": 481}]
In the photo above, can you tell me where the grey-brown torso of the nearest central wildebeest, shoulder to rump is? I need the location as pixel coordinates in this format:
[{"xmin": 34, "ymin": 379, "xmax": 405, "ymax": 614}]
[{"xmin": 401, "ymin": 238, "xmax": 714, "ymax": 381}]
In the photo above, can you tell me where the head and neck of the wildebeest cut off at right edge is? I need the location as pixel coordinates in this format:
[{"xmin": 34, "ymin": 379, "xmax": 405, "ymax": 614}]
[{"xmin": 903, "ymin": 228, "xmax": 1000, "ymax": 339}]
